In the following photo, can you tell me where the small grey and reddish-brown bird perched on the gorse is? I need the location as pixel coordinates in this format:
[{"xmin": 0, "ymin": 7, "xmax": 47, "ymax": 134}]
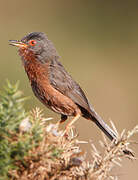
[{"xmin": 10, "ymin": 32, "xmax": 116, "ymax": 140}]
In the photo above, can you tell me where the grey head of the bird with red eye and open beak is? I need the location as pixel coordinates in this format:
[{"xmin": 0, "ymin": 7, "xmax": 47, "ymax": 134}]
[{"xmin": 10, "ymin": 32, "xmax": 58, "ymax": 63}]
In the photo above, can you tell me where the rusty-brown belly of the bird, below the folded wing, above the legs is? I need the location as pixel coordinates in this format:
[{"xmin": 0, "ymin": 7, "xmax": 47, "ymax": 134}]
[{"xmin": 31, "ymin": 81, "xmax": 81, "ymax": 116}]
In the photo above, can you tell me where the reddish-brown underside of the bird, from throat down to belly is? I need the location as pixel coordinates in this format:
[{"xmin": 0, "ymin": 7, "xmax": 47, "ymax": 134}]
[{"xmin": 20, "ymin": 48, "xmax": 81, "ymax": 116}]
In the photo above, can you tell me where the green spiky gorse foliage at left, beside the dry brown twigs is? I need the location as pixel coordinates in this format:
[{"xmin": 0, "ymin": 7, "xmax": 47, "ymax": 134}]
[{"xmin": 0, "ymin": 81, "xmax": 41, "ymax": 180}]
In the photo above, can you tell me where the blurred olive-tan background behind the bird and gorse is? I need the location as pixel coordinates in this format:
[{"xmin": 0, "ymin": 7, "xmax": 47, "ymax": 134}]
[{"xmin": 0, "ymin": 0, "xmax": 138, "ymax": 180}]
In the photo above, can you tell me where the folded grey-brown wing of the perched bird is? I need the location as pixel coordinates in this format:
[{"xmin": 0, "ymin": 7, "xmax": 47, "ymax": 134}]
[{"xmin": 49, "ymin": 60, "xmax": 90, "ymax": 112}]
